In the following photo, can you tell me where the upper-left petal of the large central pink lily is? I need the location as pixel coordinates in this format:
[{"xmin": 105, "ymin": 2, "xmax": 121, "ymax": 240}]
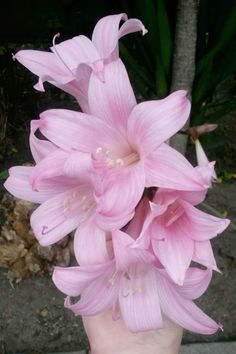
[{"xmin": 40, "ymin": 109, "xmax": 128, "ymax": 153}]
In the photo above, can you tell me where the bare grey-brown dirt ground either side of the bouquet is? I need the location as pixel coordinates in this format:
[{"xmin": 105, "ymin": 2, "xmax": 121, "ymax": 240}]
[{"xmin": 0, "ymin": 182, "xmax": 236, "ymax": 354}]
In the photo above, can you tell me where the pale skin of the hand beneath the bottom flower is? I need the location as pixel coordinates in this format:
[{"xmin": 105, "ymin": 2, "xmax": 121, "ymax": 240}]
[{"xmin": 83, "ymin": 311, "xmax": 183, "ymax": 354}]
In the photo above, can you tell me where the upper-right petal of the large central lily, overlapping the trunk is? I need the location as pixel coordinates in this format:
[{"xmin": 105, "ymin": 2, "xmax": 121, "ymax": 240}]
[{"xmin": 128, "ymin": 90, "xmax": 190, "ymax": 155}]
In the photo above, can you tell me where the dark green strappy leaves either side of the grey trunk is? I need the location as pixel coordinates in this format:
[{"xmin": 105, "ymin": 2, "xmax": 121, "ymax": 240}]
[{"xmin": 121, "ymin": 0, "xmax": 236, "ymax": 129}]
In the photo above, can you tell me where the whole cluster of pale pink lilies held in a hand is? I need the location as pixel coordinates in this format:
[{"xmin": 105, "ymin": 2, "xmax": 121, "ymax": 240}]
[{"xmin": 5, "ymin": 14, "xmax": 229, "ymax": 334}]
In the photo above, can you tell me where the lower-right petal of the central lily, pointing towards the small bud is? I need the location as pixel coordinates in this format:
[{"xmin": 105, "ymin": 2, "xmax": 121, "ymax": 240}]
[{"xmin": 145, "ymin": 144, "xmax": 209, "ymax": 191}]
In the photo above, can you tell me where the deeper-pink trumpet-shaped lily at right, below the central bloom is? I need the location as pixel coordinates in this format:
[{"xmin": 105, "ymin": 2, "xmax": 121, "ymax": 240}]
[{"xmin": 136, "ymin": 189, "xmax": 230, "ymax": 285}]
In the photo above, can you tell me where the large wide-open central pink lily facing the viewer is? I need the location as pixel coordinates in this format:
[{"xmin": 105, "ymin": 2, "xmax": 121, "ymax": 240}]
[{"xmin": 32, "ymin": 59, "xmax": 214, "ymax": 230}]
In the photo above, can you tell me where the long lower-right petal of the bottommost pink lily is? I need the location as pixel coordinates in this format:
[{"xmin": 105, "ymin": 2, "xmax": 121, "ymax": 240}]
[{"xmin": 157, "ymin": 276, "xmax": 220, "ymax": 334}]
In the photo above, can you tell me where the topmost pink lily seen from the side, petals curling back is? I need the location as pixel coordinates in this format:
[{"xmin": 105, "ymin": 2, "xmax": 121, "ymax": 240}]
[{"xmin": 14, "ymin": 14, "xmax": 147, "ymax": 112}]
